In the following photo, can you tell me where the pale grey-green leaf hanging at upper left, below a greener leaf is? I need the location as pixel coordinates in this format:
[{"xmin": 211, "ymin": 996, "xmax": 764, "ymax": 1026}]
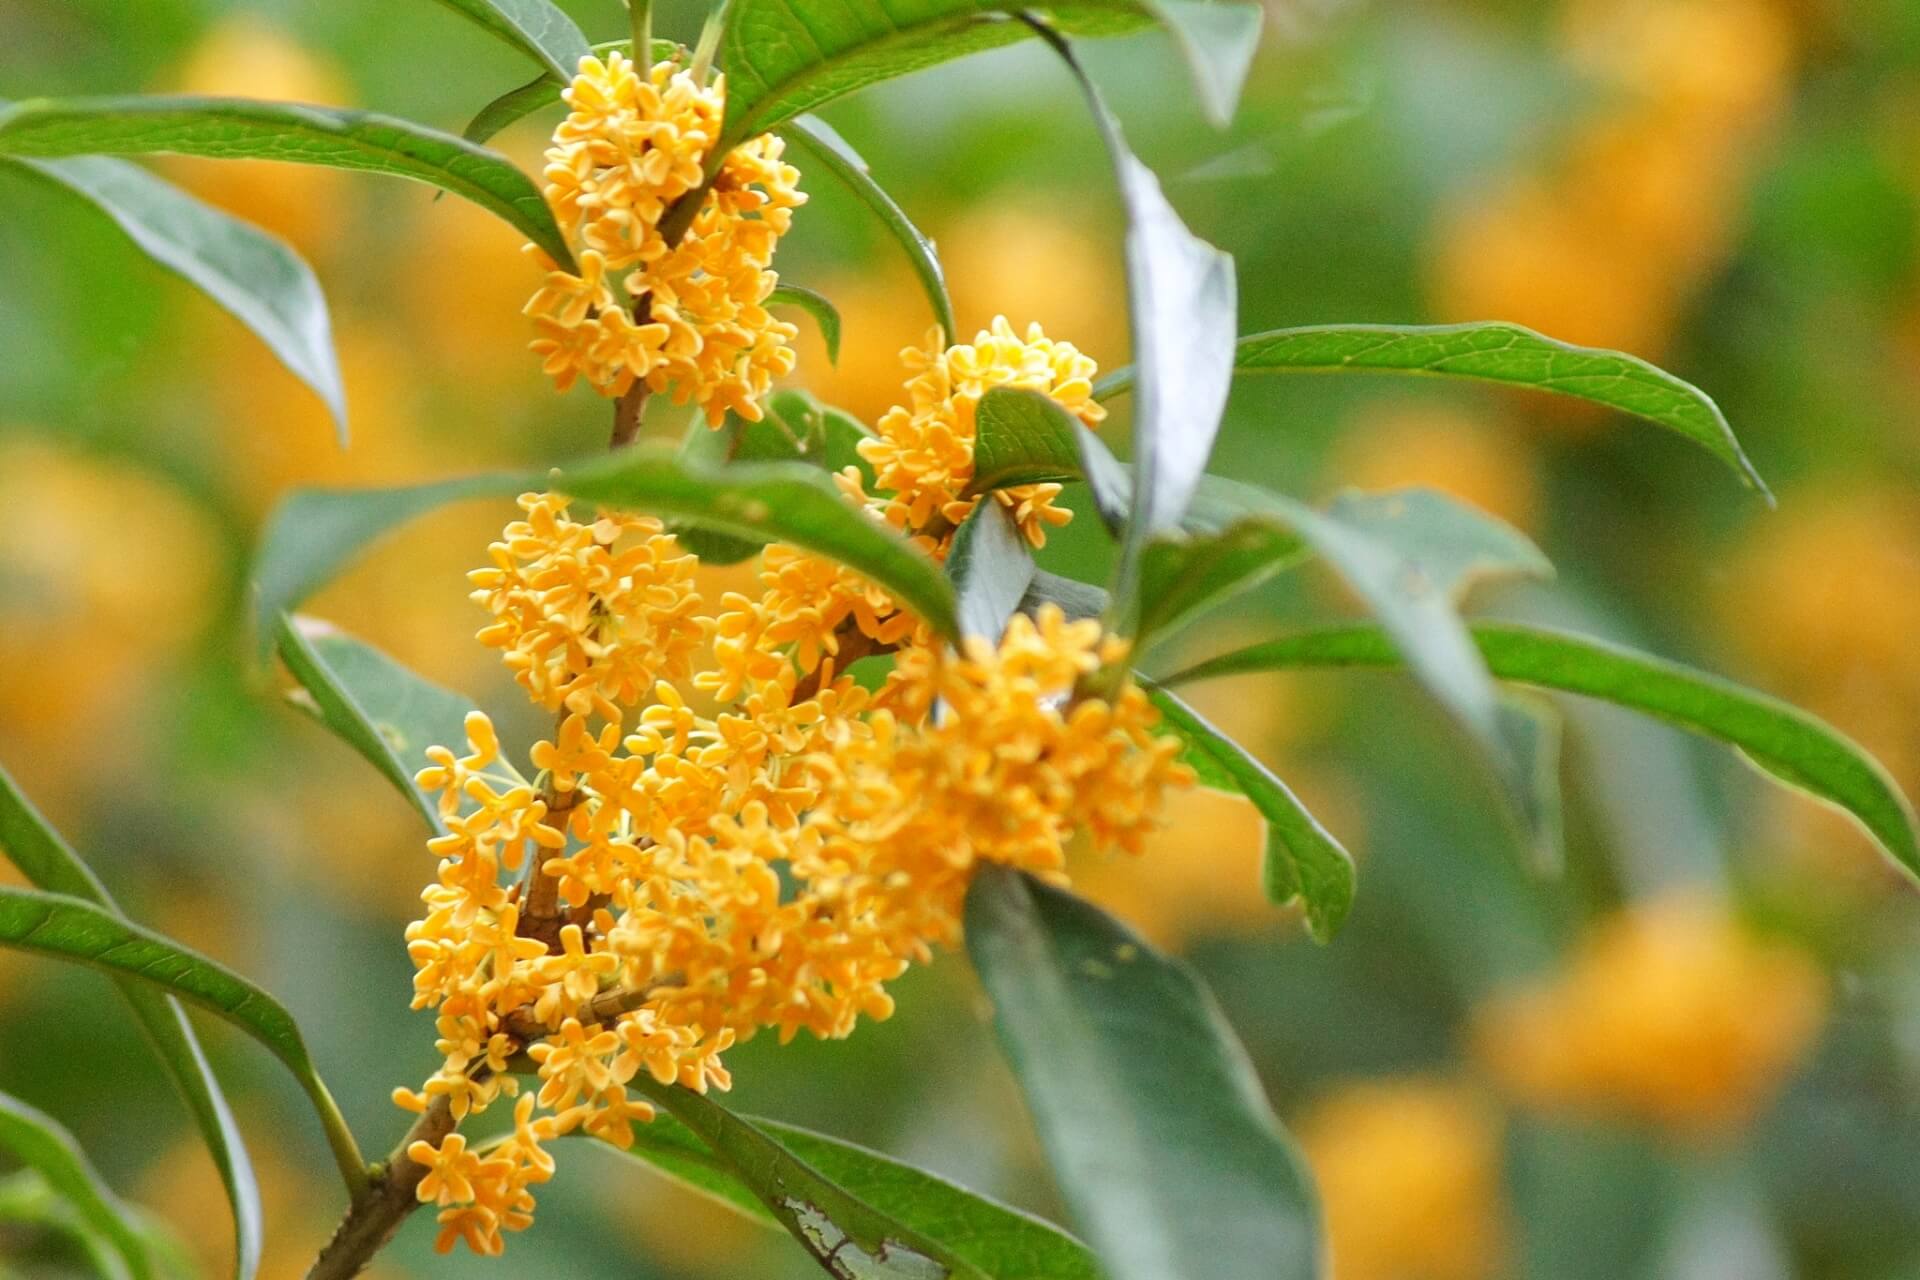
[{"xmin": 13, "ymin": 155, "xmax": 348, "ymax": 445}]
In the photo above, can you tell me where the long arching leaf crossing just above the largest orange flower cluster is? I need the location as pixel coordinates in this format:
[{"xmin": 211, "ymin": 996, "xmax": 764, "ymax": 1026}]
[{"xmin": 253, "ymin": 447, "xmax": 956, "ymax": 652}]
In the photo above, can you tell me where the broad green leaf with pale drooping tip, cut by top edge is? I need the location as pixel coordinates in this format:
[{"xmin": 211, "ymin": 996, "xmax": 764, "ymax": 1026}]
[{"xmin": 720, "ymin": 0, "xmax": 1260, "ymax": 148}]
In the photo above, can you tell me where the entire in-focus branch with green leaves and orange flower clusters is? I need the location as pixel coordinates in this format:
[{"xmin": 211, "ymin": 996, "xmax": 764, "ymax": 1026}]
[{"xmin": 0, "ymin": 0, "xmax": 1920, "ymax": 1280}]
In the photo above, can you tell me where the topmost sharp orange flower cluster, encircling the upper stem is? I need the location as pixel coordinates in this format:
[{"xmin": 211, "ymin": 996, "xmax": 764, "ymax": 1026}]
[{"xmin": 526, "ymin": 54, "xmax": 806, "ymax": 426}]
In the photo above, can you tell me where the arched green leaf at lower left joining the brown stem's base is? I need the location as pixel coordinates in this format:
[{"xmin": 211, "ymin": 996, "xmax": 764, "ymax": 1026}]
[{"xmin": 0, "ymin": 887, "xmax": 367, "ymax": 1194}]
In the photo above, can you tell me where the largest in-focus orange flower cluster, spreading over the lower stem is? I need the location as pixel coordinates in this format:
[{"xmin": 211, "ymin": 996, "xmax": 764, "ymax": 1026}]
[{"xmin": 396, "ymin": 468, "xmax": 1190, "ymax": 1253}]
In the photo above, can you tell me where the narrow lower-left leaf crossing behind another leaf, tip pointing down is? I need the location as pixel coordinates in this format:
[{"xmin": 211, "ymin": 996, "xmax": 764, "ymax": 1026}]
[{"xmin": 0, "ymin": 770, "xmax": 263, "ymax": 1280}]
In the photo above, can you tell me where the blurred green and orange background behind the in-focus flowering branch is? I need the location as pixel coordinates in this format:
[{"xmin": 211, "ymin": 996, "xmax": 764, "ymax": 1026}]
[{"xmin": 0, "ymin": 0, "xmax": 1920, "ymax": 1280}]
